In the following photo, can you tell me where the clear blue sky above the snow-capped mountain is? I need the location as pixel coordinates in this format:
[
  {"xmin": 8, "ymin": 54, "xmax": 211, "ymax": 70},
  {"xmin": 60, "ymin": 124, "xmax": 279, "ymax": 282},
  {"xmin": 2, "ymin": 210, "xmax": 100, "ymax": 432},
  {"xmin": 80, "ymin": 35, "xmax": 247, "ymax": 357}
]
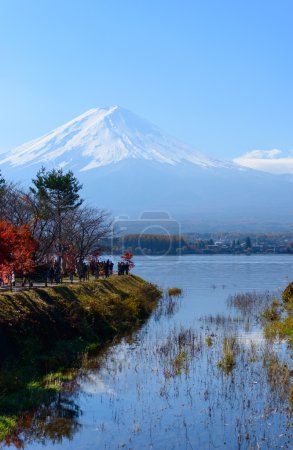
[{"xmin": 0, "ymin": 0, "xmax": 293, "ymax": 159}]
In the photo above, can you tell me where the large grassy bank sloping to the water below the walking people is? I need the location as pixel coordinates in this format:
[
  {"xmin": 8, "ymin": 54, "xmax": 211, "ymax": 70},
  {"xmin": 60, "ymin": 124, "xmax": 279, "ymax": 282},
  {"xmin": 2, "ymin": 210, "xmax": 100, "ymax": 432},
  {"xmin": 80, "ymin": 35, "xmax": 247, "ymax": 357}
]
[{"xmin": 0, "ymin": 275, "xmax": 161, "ymax": 439}]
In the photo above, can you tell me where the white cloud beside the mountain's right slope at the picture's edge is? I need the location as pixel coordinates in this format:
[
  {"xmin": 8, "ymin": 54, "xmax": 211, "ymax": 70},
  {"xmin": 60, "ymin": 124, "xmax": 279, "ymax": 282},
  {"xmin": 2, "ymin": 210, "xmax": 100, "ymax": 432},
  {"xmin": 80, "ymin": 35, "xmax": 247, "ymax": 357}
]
[{"xmin": 233, "ymin": 149, "xmax": 293, "ymax": 174}]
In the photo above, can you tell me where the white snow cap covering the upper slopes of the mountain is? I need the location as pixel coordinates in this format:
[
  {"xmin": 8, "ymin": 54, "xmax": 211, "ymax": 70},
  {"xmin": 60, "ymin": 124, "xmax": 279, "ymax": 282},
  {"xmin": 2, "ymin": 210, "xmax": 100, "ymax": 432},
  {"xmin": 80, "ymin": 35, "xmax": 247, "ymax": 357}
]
[{"xmin": 0, "ymin": 106, "xmax": 229, "ymax": 171}]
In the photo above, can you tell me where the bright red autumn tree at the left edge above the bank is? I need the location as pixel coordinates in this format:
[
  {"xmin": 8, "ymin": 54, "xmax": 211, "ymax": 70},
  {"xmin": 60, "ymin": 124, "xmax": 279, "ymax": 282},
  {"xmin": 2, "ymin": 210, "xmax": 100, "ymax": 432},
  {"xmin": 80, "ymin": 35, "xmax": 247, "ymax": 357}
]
[{"xmin": 0, "ymin": 221, "xmax": 37, "ymax": 273}]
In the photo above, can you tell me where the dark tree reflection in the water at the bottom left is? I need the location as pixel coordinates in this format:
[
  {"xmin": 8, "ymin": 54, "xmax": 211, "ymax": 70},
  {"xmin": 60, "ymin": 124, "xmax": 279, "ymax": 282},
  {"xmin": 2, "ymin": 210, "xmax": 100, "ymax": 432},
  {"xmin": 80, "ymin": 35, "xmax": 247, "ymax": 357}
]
[{"xmin": 5, "ymin": 394, "xmax": 81, "ymax": 449}]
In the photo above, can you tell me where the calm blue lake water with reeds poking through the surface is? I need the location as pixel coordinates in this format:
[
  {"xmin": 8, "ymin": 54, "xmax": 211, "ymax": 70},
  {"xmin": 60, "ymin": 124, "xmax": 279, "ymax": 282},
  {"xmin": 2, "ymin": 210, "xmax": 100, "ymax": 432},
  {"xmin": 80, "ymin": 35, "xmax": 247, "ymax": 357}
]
[{"xmin": 4, "ymin": 255, "xmax": 293, "ymax": 450}]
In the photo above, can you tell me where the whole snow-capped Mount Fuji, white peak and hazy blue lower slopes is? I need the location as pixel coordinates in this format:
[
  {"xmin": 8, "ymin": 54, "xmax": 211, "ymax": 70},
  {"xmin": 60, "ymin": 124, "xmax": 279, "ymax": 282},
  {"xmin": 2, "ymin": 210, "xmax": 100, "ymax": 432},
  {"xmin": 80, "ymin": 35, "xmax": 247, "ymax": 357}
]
[{"xmin": 0, "ymin": 106, "xmax": 293, "ymax": 230}]
